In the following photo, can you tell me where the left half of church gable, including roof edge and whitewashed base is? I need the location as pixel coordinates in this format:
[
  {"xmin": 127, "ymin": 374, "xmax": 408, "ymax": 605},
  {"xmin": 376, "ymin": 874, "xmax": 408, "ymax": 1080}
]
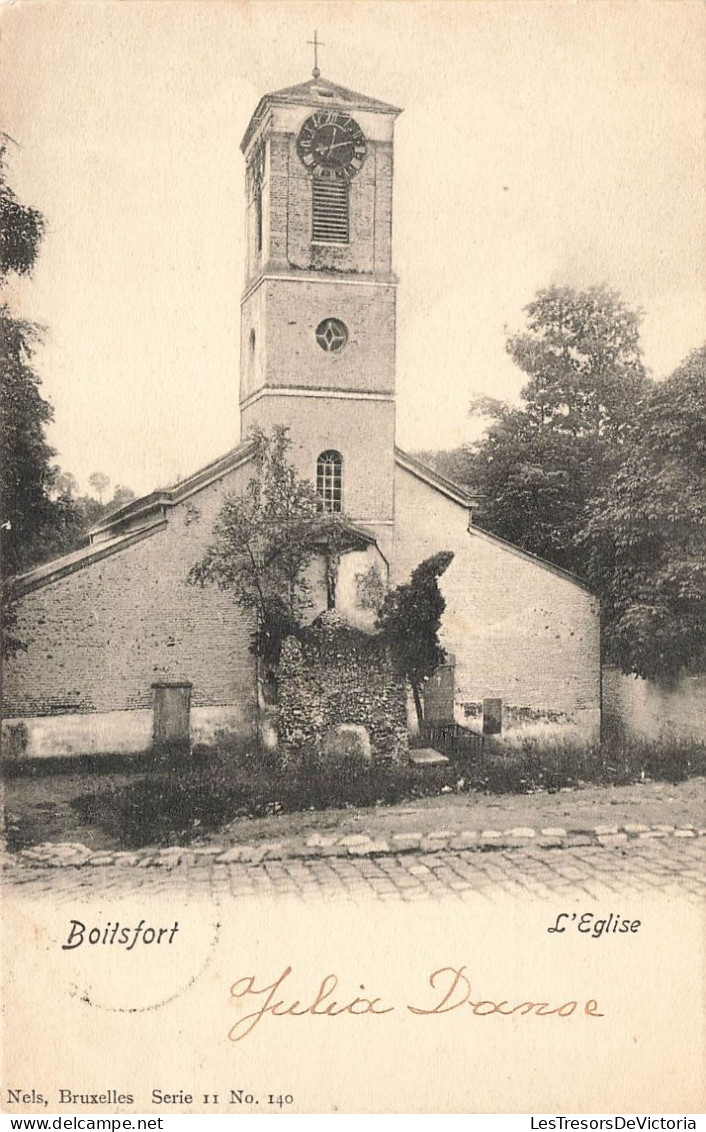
[{"xmin": 3, "ymin": 456, "xmax": 256, "ymax": 755}]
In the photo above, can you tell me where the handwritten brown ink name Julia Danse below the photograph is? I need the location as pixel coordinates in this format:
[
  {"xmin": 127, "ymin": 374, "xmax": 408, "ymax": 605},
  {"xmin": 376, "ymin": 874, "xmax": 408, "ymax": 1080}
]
[{"xmin": 229, "ymin": 967, "xmax": 604, "ymax": 1041}]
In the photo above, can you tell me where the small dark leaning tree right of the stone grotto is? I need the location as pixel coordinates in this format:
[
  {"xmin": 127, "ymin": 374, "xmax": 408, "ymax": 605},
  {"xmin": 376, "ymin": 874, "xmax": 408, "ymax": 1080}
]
[{"xmin": 377, "ymin": 550, "xmax": 454, "ymax": 727}]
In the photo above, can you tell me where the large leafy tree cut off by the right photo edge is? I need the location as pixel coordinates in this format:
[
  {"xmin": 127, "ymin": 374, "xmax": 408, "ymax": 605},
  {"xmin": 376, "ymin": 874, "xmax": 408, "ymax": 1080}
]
[{"xmin": 584, "ymin": 346, "xmax": 706, "ymax": 680}]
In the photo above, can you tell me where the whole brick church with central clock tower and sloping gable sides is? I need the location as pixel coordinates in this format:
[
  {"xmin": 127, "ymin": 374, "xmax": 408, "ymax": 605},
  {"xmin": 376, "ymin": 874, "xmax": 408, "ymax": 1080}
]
[{"xmin": 3, "ymin": 70, "xmax": 600, "ymax": 757}]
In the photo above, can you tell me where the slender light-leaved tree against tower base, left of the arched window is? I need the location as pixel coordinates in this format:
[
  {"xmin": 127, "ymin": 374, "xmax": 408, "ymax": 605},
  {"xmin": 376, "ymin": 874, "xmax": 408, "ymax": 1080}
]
[{"xmin": 189, "ymin": 427, "xmax": 345, "ymax": 669}]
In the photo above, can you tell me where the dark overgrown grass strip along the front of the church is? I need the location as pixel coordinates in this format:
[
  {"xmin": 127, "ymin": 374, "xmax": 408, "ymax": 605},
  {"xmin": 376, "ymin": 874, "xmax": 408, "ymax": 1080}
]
[{"xmin": 70, "ymin": 740, "xmax": 706, "ymax": 849}]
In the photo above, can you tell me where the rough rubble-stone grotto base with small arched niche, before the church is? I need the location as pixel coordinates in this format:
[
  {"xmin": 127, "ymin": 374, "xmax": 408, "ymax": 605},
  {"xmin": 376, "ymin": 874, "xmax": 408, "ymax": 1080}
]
[{"xmin": 277, "ymin": 612, "xmax": 408, "ymax": 760}]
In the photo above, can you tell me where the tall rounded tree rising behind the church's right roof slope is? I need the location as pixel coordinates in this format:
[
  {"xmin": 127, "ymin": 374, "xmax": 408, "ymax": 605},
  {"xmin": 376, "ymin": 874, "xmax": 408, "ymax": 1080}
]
[{"xmin": 467, "ymin": 286, "xmax": 649, "ymax": 575}]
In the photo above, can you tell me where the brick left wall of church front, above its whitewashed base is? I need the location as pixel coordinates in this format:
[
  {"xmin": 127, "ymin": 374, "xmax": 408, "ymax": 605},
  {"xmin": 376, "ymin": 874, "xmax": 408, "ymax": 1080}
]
[{"xmin": 5, "ymin": 468, "xmax": 255, "ymax": 718}]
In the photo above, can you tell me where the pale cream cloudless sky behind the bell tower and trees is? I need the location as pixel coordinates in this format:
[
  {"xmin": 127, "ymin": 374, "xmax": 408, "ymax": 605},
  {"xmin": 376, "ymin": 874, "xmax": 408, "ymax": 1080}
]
[{"xmin": 0, "ymin": 0, "xmax": 706, "ymax": 494}]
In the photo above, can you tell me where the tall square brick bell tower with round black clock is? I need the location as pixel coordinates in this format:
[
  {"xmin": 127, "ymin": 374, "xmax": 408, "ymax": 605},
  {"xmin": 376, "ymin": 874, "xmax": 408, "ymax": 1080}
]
[{"xmin": 240, "ymin": 71, "xmax": 399, "ymax": 554}]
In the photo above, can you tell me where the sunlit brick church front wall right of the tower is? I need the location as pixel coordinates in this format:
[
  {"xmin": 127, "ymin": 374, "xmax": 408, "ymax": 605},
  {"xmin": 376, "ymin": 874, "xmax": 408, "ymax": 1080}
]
[{"xmin": 393, "ymin": 466, "xmax": 600, "ymax": 737}]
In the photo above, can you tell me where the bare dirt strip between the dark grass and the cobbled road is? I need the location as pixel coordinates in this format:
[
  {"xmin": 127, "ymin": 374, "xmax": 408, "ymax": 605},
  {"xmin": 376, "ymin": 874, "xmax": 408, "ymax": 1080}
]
[{"xmin": 3, "ymin": 767, "xmax": 706, "ymax": 849}]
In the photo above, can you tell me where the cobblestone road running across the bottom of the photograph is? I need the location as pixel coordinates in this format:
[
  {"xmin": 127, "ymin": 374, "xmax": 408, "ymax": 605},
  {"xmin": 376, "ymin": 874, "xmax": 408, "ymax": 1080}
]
[{"xmin": 5, "ymin": 838, "xmax": 706, "ymax": 902}]
